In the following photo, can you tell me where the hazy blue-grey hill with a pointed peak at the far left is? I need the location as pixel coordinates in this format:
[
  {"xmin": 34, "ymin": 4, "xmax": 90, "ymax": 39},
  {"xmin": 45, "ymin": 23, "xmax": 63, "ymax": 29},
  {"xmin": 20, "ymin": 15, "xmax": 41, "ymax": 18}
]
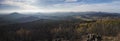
[{"xmin": 0, "ymin": 12, "xmax": 39, "ymax": 24}]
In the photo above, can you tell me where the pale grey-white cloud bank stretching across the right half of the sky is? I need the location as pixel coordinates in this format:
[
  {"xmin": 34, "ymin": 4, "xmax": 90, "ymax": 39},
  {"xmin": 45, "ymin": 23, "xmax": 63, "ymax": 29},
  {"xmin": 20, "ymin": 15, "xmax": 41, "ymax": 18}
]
[{"xmin": 48, "ymin": 1, "xmax": 120, "ymax": 12}]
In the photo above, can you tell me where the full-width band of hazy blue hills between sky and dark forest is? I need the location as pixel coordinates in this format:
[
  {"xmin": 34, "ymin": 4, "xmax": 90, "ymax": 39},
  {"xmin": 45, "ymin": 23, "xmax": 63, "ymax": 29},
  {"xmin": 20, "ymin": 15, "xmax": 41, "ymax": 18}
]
[{"xmin": 0, "ymin": 12, "xmax": 120, "ymax": 24}]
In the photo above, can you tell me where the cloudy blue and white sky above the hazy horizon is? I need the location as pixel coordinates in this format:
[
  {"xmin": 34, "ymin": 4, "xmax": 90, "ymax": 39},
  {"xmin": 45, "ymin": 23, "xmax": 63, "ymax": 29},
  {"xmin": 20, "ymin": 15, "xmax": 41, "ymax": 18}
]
[{"xmin": 0, "ymin": 0, "xmax": 120, "ymax": 13}]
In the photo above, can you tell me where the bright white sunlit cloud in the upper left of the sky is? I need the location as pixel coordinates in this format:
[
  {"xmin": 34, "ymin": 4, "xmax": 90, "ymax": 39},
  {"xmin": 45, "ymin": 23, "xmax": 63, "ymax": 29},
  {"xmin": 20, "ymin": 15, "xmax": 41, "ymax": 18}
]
[{"xmin": 0, "ymin": 0, "xmax": 39, "ymax": 10}]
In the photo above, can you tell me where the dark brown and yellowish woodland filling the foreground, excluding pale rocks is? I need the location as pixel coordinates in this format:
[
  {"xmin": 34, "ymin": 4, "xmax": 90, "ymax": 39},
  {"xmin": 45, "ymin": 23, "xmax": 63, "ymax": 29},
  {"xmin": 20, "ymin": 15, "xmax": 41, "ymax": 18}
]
[{"xmin": 0, "ymin": 19, "xmax": 120, "ymax": 41}]
